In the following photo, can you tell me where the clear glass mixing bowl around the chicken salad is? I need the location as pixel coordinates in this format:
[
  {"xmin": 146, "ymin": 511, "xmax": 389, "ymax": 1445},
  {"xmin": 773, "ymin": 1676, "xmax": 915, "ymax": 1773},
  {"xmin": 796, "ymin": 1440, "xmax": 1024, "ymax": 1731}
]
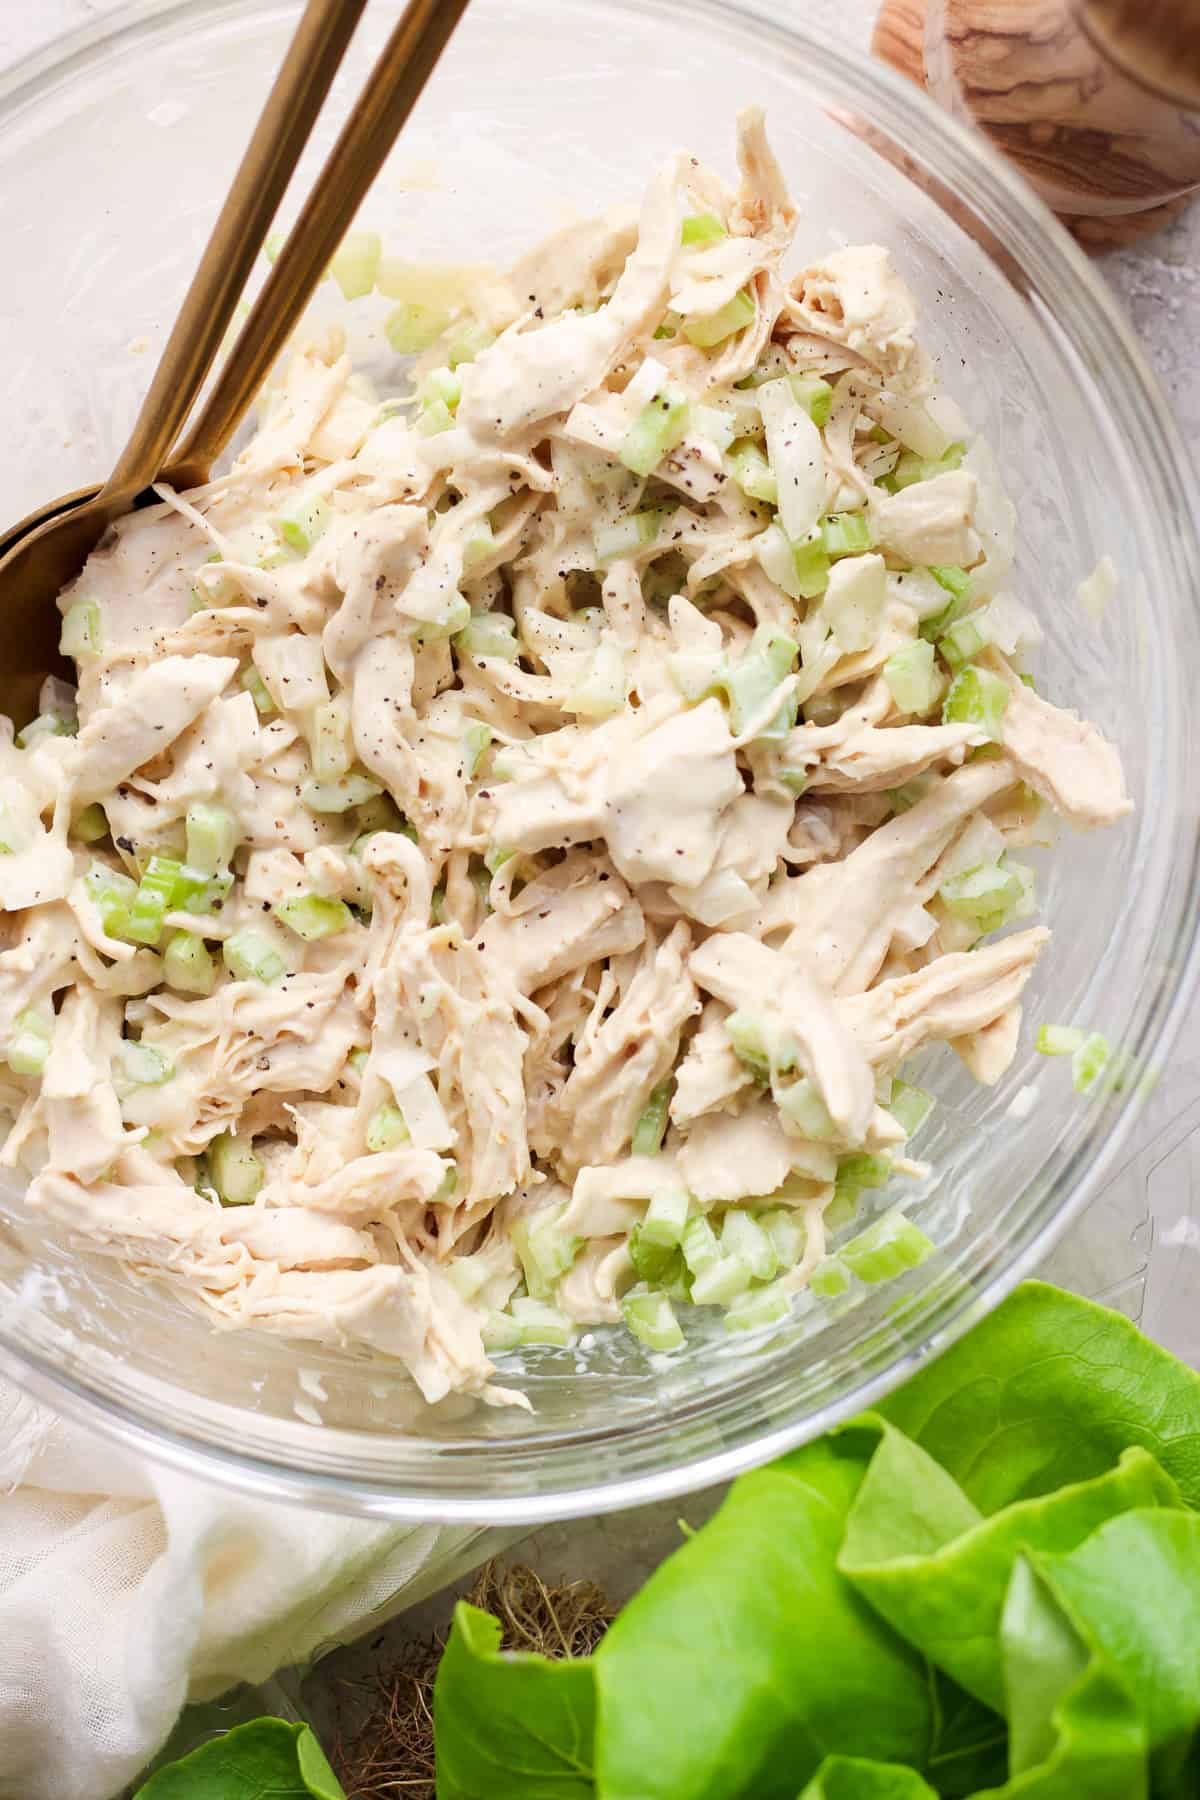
[{"xmin": 0, "ymin": 0, "xmax": 1200, "ymax": 1525}]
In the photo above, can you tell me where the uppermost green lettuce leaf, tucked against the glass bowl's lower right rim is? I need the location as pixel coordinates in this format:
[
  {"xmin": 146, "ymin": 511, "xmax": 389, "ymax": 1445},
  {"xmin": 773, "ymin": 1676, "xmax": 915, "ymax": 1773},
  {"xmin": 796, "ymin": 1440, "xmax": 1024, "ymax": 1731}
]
[{"xmin": 878, "ymin": 1282, "xmax": 1200, "ymax": 1514}]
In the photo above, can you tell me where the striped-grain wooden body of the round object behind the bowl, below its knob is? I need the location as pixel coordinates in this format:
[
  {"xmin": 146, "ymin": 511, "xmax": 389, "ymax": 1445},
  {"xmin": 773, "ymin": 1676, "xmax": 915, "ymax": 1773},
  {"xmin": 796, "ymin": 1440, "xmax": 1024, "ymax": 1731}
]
[{"xmin": 873, "ymin": 0, "xmax": 1200, "ymax": 250}]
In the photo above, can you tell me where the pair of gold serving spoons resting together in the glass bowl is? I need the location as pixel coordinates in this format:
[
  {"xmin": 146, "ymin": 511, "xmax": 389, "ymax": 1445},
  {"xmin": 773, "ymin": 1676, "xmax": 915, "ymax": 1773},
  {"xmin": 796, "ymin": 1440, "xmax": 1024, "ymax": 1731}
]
[{"xmin": 0, "ymin": 0, "xmax": 468, "ymax": 724}]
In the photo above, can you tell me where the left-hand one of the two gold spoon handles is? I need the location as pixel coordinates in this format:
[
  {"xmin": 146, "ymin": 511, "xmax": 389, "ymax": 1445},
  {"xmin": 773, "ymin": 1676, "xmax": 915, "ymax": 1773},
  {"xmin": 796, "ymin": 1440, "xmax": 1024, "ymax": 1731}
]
[{"xmin": 101, "ymin": 0, "xmax": 367, "ymax": 517}]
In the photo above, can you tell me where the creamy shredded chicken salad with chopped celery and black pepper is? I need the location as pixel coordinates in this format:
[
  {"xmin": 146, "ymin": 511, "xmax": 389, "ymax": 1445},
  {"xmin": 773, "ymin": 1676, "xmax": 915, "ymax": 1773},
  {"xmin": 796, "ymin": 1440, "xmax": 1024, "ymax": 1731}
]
[{"xmin": 0, "ymin": 112, "xmax": 1128, "ymax": 1404}]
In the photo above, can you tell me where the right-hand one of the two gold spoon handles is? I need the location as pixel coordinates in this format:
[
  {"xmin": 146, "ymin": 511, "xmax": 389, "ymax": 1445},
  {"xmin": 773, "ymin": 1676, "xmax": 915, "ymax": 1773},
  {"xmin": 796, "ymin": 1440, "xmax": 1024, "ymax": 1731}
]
[{"xmin": 162, "ymin": 0, "xmax": 466, "ymax": 488}]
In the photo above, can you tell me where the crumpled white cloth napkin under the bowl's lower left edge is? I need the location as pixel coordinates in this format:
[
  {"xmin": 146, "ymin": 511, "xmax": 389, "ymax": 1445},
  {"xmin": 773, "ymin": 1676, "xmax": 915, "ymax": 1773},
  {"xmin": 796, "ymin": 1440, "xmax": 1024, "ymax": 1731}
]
[{"xmin": 0, "ymin": 1382, "xmax": 489, "ymax": 1800}]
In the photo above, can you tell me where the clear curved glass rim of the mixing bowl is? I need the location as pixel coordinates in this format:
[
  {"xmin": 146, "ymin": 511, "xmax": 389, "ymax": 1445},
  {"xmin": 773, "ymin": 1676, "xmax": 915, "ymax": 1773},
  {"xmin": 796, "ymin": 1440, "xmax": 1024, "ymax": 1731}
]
[{"xmin": 0, "ymin": 0, "xmax": 1200, "ymax": 1525}]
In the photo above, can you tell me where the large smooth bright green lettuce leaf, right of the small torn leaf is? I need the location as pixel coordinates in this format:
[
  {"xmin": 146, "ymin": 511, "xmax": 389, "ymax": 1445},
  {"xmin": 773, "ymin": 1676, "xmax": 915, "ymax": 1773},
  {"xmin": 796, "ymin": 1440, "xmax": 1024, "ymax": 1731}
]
[{"xmin": 596, "ymin": 1427, "xmax": 934, "ymax": 1800}]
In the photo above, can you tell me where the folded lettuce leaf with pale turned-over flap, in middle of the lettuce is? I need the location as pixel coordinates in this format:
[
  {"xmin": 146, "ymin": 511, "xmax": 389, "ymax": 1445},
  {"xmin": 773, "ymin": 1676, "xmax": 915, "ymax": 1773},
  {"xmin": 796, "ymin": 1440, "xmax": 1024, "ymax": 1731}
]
[{"xmin": 838, "ymin": 1431, "xmax": 1182, "ymax": 1712}]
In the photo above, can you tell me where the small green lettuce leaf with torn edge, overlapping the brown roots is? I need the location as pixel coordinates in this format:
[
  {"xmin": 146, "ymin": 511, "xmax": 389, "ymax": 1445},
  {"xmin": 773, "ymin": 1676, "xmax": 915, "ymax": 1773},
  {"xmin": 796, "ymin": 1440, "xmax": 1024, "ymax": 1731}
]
[{"xmin": 434, "ymin": 1600, "xmax": 596, "ymax": 1800}]
